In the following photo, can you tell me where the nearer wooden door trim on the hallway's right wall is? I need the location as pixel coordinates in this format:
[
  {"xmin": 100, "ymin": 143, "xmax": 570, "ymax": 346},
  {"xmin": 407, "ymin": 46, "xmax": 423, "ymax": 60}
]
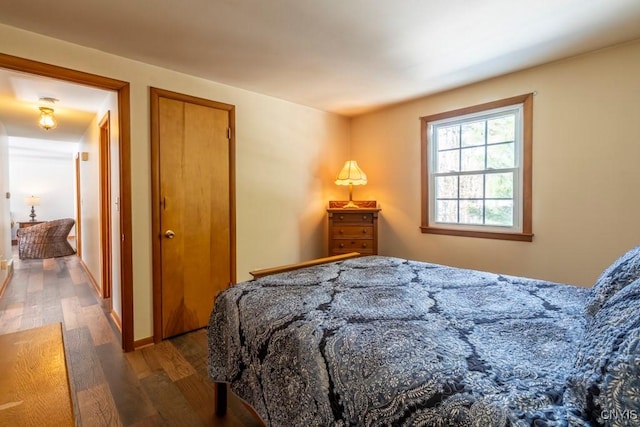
[{"xmin": 99, "ymin": 111, "xmax": 113, "ymax": 300}]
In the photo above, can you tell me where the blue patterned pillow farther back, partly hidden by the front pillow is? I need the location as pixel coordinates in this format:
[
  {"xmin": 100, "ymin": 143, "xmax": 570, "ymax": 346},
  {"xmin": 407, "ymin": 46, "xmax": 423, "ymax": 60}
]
[{"xmin": 584, "ymin": 246, "xmax": 640, "ymax": 319}]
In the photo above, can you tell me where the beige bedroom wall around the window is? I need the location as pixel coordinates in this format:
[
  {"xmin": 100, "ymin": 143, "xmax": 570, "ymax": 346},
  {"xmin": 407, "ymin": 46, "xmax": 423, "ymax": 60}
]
[{"xmin": 352, "ymin": 41, "xmax": 640, "ymax": 286}]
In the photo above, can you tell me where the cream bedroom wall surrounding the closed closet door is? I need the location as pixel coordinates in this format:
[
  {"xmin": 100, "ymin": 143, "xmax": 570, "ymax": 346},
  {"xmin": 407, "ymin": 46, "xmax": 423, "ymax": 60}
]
[{"xmin": 0, "ymin": 25, "xmax": 349, "ymax": 340}]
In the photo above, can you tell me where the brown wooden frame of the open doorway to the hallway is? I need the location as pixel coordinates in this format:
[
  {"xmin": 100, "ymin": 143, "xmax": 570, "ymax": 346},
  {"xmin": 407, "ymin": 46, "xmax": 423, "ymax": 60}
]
[{"xmin": 0, "ymin": 53, "xmax": 135, "ymax": 351}]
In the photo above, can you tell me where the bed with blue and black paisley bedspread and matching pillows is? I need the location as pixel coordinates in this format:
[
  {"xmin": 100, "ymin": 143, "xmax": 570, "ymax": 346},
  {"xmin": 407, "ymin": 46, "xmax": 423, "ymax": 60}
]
[{"xmin": 208, "ymin": 246, "xmax": 640, "ymax": 426}]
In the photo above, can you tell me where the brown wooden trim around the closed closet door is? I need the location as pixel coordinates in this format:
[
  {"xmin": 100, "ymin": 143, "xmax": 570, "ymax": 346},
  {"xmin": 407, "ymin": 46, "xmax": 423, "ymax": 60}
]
[{"xmin": 149, "ymin": 87, "xmax": 236, "ymax": 343}]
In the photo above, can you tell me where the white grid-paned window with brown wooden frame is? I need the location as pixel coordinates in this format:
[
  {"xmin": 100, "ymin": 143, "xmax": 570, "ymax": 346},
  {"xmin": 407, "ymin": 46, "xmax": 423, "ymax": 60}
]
[{"xmin": 420, "ymin": 94, "xmax": 533, "ymax": 241}]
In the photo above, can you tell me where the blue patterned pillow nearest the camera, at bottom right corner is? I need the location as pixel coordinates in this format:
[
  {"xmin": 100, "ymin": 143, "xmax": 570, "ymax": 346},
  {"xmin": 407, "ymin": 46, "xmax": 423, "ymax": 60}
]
[{"xmin": 565, "ymin": 280, "xmax": 640, "ymax": 426}]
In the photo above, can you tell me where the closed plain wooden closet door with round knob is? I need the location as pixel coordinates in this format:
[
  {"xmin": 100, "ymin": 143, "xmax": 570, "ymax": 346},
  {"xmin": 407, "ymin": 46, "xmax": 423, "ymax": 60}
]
[{"xmin": 158, "ymin": 97, "xmax": 232, "ymax": 339}]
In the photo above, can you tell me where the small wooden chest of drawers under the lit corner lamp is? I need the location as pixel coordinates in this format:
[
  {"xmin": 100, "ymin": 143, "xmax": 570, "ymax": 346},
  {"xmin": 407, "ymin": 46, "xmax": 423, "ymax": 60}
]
[{"xmin": 327, "ymin": 202, "xmax": 380, "ymax": 256}]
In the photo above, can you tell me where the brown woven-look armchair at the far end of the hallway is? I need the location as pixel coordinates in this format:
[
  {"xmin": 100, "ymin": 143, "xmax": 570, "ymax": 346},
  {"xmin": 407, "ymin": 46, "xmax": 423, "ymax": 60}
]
[{"xmin": 18, "ymin": 218, "xmax": 76, "ymax": 259}]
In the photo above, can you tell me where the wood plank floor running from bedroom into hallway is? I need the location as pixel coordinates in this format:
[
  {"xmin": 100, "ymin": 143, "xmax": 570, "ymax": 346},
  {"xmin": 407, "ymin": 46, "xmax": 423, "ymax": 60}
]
[{"xmin": 0, "ymin": 252, "xmax": 262, "ymax": 427}]
